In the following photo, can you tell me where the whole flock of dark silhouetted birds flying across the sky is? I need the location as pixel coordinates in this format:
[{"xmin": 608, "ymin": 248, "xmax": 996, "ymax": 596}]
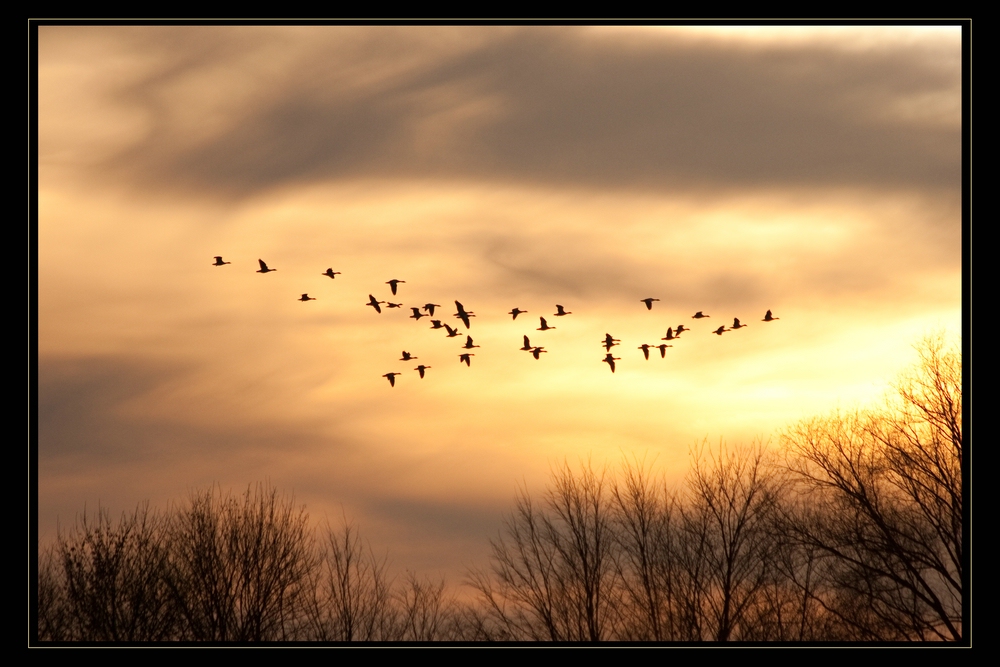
[{"xmin": 213, "ymin": 256, "xmax": 781, "ymax": 387}]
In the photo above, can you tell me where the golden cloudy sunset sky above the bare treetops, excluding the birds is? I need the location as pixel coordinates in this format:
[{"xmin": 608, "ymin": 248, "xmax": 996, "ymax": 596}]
[{"xmin": 37, "ymin": 26, "xmax": 962, "ymax": 585}]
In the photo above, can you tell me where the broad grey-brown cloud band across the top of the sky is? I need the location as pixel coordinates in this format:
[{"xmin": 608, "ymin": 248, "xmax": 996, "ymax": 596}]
[{"xmin": 66, "ymin": 27, "xmax": 961, "ymax": 196}]
